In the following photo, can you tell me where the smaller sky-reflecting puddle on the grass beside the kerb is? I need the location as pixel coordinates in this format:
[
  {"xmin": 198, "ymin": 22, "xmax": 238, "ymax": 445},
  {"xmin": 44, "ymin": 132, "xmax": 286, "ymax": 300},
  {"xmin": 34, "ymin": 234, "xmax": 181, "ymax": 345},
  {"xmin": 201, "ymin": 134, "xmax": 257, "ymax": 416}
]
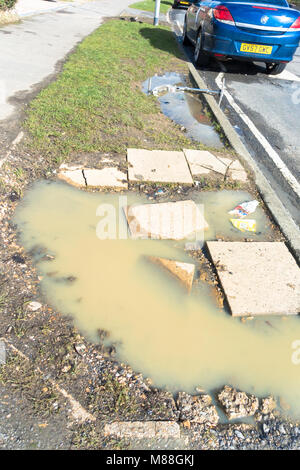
[{"xmin": 142, "ymin": 72, "xmax": 223, "ymax": 148}]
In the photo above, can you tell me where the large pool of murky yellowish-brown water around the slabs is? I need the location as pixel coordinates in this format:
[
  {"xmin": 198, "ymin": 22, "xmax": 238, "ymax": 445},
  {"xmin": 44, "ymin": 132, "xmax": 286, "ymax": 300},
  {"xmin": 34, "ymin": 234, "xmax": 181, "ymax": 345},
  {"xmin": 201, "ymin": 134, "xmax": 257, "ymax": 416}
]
[{"xmin": 15, "ymin": 182, "xmax": 300, "ymax": 416}]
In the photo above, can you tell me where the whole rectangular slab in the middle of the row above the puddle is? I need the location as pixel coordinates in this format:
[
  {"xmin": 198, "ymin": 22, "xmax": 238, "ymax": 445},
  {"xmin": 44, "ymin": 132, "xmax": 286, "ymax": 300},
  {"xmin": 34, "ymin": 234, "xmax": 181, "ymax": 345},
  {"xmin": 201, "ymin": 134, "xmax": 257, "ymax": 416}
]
[{"xmin": 127, "ymin": 149, "xmax": 193, "ymax": 185}]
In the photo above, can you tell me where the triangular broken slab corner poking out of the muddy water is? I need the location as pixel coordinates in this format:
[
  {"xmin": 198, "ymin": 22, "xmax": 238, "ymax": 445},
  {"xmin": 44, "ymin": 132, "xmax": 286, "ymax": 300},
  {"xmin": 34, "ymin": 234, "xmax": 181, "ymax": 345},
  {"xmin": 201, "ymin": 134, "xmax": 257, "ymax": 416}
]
[{"xmin": 148, "ymin": 256, "xmax": 195, "ymax": 292}]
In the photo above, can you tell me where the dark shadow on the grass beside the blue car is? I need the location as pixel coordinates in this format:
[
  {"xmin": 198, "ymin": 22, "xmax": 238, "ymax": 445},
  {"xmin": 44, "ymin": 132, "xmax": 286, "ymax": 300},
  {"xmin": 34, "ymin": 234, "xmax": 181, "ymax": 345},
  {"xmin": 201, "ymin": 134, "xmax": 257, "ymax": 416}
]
[{"xmin": 140, "ymin": 28, "xmax": 183, "ymax": 59}]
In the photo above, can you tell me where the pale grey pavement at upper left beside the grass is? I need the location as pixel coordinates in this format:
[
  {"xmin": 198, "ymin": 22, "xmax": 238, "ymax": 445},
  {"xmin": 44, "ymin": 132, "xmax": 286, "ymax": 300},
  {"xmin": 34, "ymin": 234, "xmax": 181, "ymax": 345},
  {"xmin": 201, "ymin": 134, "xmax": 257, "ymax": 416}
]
[{"xmin": 0, "ymin": 0, "xmax": 132, "ymax": 132}]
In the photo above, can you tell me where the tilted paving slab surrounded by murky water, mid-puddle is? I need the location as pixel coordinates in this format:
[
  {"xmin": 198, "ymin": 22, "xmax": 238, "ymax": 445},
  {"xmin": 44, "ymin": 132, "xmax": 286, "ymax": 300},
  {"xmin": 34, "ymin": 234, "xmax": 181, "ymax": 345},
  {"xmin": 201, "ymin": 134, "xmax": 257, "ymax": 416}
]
[{"xmin": 123, "ymin": 200, "xmax": 208, "ymax": 240}]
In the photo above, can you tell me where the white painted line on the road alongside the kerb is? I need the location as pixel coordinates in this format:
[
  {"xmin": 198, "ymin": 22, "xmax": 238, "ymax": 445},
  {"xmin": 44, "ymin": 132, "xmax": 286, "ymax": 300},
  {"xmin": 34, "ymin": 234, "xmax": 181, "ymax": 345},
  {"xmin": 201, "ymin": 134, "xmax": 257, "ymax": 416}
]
[{"xmin": 215, "ymin": 72, "xmax": 300, "ymax": 197}]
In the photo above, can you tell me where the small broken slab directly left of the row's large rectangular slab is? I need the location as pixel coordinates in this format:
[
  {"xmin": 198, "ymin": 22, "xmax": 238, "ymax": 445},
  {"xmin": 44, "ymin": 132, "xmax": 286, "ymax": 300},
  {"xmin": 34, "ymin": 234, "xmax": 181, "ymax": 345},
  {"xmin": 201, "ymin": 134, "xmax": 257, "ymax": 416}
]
[{"xmin": 83, "ymin": 167, "xmax": 128, "ymax": 189}]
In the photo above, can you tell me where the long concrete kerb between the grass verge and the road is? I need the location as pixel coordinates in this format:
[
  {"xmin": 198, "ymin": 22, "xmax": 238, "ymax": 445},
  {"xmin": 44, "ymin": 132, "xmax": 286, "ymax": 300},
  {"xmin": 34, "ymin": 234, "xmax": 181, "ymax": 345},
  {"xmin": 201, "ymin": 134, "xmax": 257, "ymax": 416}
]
[{"xmin": 188, "ymin": 62, "xmax": 300, "ymax": 265}]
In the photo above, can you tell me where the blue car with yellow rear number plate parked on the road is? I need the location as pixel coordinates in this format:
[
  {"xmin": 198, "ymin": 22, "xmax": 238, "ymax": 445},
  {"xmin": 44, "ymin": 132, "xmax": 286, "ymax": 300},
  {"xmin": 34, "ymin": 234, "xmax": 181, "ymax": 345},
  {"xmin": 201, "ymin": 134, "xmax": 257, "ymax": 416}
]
[{"xmin": 183, "ymin": 0, "xmax": 300, "ymax": 75}]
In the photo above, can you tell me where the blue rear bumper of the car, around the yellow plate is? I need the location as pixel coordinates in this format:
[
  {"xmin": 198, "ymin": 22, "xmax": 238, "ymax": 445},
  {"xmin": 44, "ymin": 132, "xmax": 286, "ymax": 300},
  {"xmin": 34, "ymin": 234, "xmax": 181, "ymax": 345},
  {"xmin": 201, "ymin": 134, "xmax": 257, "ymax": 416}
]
[{"xmin": 203, "ymin": 23, "xmax": 300, "ymax": 62}]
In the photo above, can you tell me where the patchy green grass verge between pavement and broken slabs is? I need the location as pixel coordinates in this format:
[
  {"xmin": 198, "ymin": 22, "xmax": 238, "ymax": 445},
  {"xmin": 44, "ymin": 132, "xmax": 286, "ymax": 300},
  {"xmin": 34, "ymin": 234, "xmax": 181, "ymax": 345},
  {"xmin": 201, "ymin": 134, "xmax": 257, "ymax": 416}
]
[{"xmin": 25, "ymin": 20, "xmax": 206, "ymax": 163}]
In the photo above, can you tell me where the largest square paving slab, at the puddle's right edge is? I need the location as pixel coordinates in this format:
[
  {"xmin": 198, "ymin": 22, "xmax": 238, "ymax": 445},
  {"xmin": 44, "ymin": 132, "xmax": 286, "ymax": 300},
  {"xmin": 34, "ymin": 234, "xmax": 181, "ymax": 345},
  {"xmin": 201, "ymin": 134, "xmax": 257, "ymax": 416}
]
[{"xmin": 207, "ymin": 242, "xmax": 300, "ymax": 316}]
